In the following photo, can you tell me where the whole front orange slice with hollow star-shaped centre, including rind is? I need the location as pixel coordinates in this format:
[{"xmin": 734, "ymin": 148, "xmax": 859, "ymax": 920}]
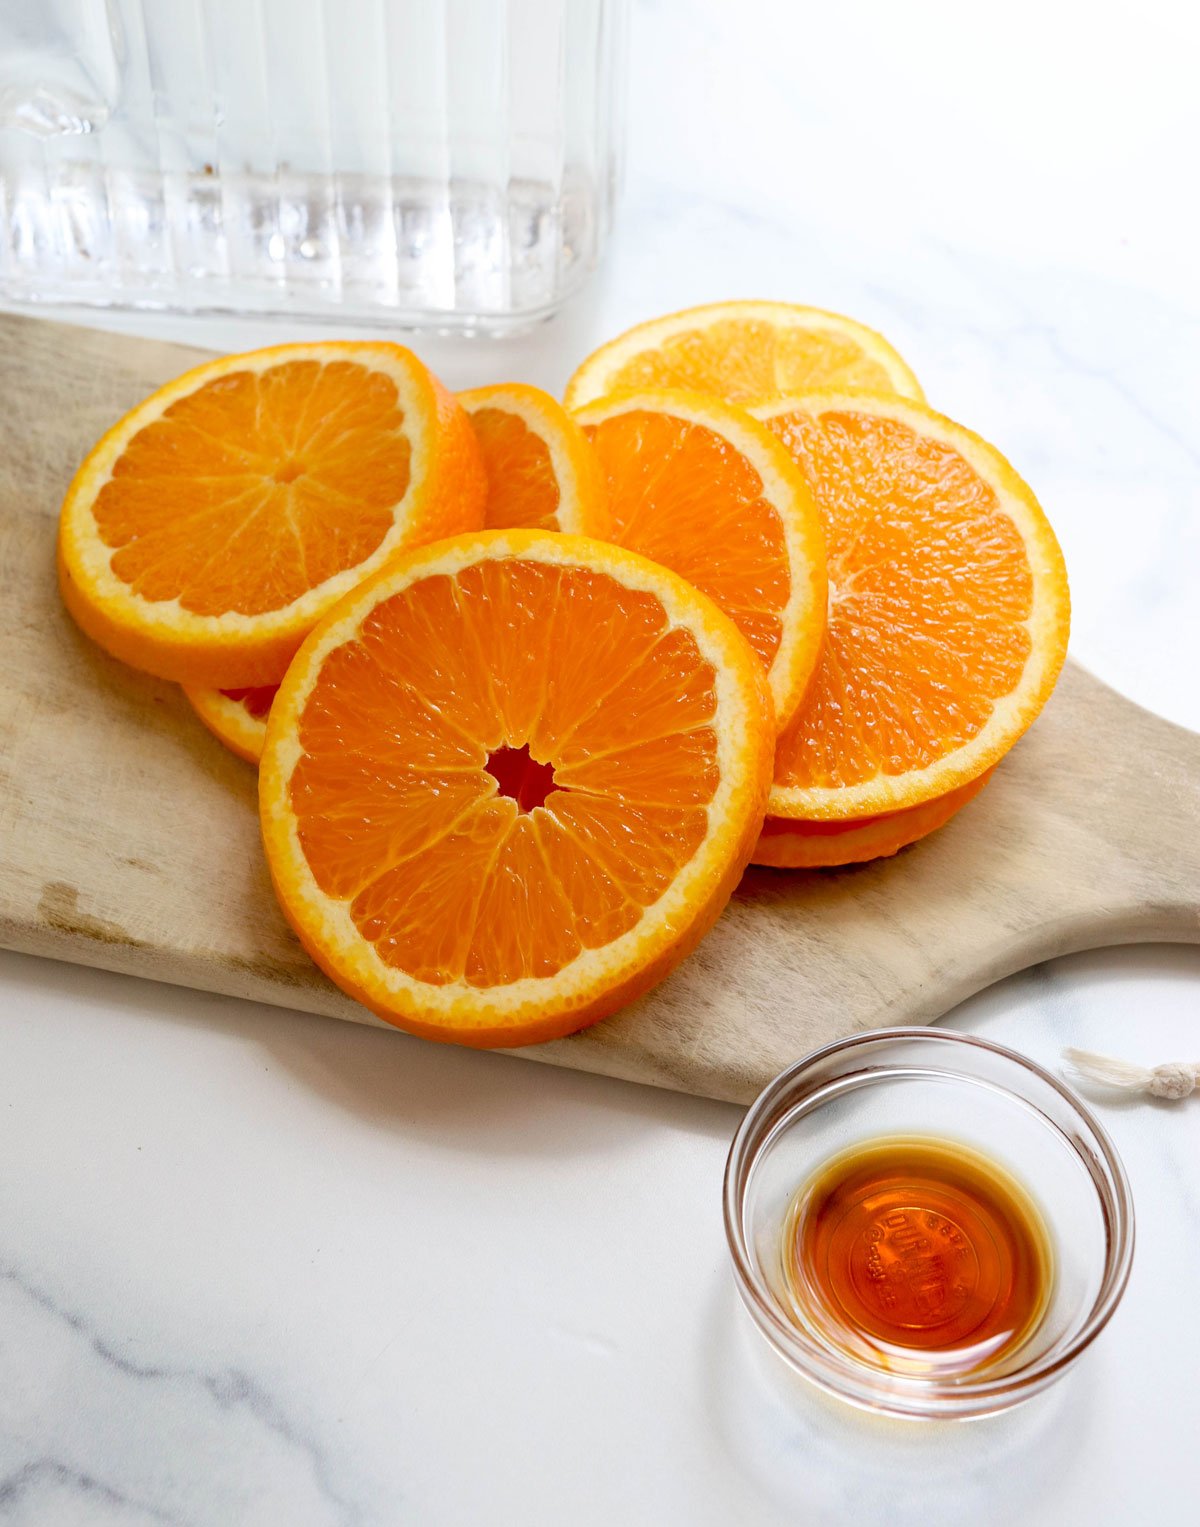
[{"xmin": 260, "ymin": 530, "xmax": 773, "ymax": 1046}]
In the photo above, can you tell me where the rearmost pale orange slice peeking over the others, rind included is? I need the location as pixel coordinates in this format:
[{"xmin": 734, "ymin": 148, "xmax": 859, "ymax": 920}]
[{"xmin": 565, "ymin": 302, "xmax": 924, "ymax": 409}]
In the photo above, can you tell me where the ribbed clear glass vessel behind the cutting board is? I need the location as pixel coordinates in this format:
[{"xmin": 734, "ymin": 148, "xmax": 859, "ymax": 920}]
[{"xmin": 0, "ymin": 0, "xmax": 626, "ymax": 331}]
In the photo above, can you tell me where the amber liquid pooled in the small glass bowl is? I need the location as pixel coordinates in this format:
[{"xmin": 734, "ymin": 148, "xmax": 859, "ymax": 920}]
[{"xmin": 782, "ymin": 1136, "xmax": 1053, "ymax": 1376}]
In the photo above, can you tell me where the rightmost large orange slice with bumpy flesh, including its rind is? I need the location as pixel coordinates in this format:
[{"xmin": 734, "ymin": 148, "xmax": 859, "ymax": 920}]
[{"xmin": 754, "ymin": 392, "xmax": 1070, "ymax": 820}]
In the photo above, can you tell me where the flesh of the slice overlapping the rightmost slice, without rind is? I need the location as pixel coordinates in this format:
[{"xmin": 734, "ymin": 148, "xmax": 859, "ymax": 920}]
[{"xmin": 585, "ymin": 409, "xmax": 791, "ymax": 681}]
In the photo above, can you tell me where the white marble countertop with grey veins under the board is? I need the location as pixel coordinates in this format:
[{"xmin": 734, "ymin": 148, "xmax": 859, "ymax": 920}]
[{"xmin": 0, "ymin": 0, "xmax": 1200, "ymax": 1527}]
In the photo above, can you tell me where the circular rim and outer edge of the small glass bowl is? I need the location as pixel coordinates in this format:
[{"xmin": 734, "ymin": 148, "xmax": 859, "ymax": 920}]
[{"xmin": 722, "ymin": 1026, "xmax": 1134, "ymax": 1417}]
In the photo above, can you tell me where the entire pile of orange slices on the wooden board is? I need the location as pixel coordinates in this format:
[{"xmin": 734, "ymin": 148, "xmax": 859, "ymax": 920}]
[{"xmin": 60, "ymin": 302, "xmax": 1069, "ymax": 1046}]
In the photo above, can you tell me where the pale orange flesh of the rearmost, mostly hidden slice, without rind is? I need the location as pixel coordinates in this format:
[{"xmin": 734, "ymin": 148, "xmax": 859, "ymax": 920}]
[{"xmin": 605, "ymin": 318, "xmax": 892, "ymax": 403}]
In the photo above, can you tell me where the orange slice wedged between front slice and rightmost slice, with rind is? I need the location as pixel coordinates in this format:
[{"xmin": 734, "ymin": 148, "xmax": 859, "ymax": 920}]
[{"xmin": 579, "ymin": 389, "xmax": 826, "ymax": 727}]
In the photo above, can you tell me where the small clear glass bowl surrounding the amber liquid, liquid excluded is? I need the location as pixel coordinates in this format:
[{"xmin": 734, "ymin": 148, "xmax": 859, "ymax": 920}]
[{"xmin": 725, "ymin": 1029, "xmax": 1133, "ymax": 1419}]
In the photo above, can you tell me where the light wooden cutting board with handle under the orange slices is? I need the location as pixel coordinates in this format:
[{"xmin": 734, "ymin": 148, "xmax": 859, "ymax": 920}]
[{"xmin": 0, "ymin": 316, "xmax": 1200, "ymax": 1102}]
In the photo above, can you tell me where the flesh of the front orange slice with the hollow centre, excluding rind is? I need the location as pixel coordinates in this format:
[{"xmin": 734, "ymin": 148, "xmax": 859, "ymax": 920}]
[{"xmin": 290, "ymin": 560, "xmax": 719, "ymax": 988}]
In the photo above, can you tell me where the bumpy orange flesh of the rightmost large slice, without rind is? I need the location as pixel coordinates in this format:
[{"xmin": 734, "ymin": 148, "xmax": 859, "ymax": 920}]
[{"xmin": 763, "ymin": 411, "xmax": 1034, "ymax": 788}]
